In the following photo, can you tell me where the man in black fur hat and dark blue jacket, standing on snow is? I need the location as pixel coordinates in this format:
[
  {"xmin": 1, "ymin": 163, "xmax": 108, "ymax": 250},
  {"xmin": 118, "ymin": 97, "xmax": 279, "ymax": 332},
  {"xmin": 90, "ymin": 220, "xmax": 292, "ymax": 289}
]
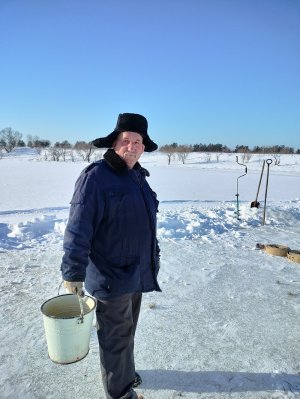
[{"xmin": 61, "ymin": 113, "xmax": 160, "ymax": 399}]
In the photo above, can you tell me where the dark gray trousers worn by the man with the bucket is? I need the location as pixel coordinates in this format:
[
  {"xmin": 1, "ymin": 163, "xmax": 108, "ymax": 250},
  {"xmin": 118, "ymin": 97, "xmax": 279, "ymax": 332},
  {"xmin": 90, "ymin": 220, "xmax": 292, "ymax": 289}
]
[{"xmin": 96, "ymin": 293, "xmax": 142, "ymax": 399}]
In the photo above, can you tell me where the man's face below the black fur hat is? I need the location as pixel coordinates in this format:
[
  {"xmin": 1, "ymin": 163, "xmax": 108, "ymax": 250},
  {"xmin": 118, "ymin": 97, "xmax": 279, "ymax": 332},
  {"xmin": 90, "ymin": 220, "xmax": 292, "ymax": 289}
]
[{"xmin": 113, "ymin": 132, "xmax": 145, "ymax": 169}]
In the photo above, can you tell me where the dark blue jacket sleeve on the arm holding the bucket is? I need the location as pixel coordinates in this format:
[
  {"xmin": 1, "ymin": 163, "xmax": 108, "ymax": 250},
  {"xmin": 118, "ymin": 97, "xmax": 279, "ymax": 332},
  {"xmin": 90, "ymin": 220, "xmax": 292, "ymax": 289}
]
[{"xmin": 61, "ymin": 173, "xmax": 104, "ymax": 281}]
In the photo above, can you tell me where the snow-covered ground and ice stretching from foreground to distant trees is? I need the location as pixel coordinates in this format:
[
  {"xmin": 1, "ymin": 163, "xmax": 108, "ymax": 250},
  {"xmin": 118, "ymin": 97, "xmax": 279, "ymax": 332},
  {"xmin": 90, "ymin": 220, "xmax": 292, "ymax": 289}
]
[{"xmin": 0, "ymin": 149, "xmax": 300, "ymax": 399}]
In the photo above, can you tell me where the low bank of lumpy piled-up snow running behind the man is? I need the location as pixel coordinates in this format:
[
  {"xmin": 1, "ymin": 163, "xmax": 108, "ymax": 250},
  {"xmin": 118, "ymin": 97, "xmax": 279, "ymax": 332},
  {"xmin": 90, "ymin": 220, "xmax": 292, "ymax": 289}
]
[{"xmin": 0, "ymin": 201, "xmax": 300, "ymax": 249}]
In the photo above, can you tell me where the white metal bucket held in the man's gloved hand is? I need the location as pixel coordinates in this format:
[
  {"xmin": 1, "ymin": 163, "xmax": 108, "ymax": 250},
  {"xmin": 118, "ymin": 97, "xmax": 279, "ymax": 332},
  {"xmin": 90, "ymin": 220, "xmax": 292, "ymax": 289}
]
[{"xmin": 41, "ymin": 294, "xmax": 96, "ymax": 364}]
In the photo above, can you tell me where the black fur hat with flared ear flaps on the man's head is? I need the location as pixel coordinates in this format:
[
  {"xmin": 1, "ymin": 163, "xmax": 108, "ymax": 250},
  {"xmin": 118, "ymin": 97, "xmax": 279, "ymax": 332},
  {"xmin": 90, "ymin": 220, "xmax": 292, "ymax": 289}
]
[{"xmin": 92, "ymin": 113, "xmax": 157, "ymax": 152}]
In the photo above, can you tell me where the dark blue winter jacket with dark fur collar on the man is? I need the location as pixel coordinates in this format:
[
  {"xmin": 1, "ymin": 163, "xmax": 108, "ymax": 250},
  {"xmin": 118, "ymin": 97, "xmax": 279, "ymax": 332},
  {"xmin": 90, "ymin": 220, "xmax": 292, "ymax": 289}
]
[{"xmin": 61, "ymin": 150, "xmax": 160, "ymax": 299}]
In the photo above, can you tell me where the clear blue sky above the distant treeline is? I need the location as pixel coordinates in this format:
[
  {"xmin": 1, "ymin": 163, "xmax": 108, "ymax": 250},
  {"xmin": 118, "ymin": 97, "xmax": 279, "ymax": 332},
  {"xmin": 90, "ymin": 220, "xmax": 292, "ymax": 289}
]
[{"xmin": 0, "ymin": 0, "xmax": 300, "ymax": 149}]
